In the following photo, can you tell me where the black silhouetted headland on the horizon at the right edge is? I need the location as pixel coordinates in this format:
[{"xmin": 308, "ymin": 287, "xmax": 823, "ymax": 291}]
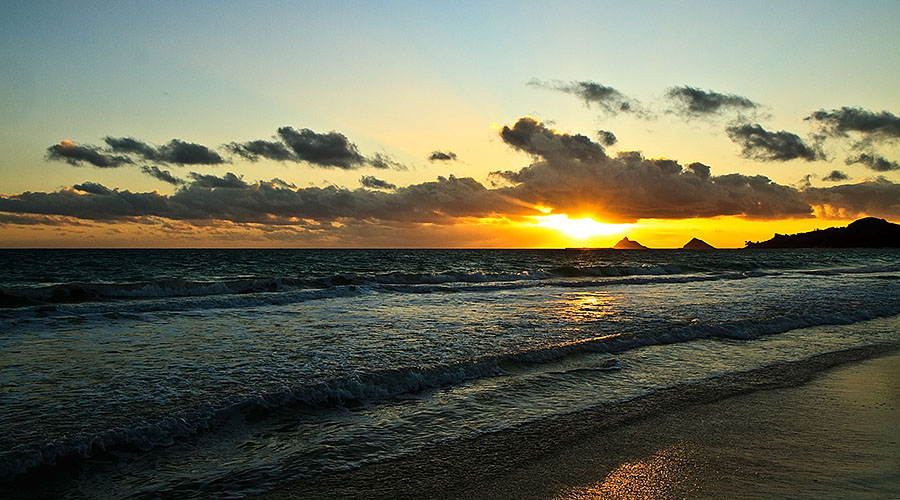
[{"xmin": 746, "ymin": 217, "xmax": 900, "ymax": 248}]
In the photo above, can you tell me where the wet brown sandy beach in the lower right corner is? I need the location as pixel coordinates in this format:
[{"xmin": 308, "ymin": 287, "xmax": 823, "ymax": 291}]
[{"xmin": 263, "ymin": 350, "xmax": 900, "ymax": 499}]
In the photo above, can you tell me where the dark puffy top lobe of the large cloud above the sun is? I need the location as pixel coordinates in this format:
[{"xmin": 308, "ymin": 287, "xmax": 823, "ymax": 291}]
[{"xmin": 500, "ymin": 117, "xmax": 606, "ymax": 161}]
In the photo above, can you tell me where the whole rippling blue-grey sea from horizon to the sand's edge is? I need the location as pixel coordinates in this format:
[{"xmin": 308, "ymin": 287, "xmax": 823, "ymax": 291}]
[{"xmin": 0, "ymin": 250, "xmax": 900, "ymax": 498}]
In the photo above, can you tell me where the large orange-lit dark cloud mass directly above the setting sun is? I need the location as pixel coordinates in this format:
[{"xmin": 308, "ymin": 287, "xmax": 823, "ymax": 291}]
[{"xmin": 492, "ymin": 118, "xmax": 810, "ymax": 222}]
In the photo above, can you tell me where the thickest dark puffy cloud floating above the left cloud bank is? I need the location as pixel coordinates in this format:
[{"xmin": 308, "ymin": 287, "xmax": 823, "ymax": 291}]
[{"xmin": 278, "ymin": 127, "xmax": 366, "ymax": 170}]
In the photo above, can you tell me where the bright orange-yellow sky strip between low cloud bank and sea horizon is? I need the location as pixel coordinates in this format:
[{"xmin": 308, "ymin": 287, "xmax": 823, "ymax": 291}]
[{"xmin": 0, "ymin": 214, "xmax": 872, "ymax": 248}]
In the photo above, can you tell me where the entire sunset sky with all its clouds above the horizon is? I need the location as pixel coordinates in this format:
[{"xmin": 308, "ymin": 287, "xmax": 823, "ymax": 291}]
[{"xmin": 0, "ymin": 0, "xmax": 900, "ymax": 248}]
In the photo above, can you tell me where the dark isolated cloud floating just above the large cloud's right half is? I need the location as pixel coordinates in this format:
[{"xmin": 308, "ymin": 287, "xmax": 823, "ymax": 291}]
[{"xmin": 725, "ymin": 123, "xmax": 825, "ymax": 161}]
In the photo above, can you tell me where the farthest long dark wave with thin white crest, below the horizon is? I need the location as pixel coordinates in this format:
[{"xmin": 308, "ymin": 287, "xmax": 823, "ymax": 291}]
[{"xmin": 0, "ymin": 262, "xmax": 900, "ymax": 309}]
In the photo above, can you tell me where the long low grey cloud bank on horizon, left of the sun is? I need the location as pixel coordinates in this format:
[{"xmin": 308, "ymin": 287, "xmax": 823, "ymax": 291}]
[{"xmin": 0, "ymin": 173, "xmax": 520, "ymax": 226}]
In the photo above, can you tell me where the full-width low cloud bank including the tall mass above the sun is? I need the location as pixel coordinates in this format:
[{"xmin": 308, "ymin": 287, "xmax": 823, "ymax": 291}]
[{"xmin": 15, "ymin": 117, "xmax": 900, "ymax": 230}]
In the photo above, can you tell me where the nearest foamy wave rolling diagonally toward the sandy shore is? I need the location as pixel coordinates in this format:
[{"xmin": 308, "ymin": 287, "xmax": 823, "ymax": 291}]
[{"xmin": 0, "ymin": 305, "xmax": 900, "ymax": 479}]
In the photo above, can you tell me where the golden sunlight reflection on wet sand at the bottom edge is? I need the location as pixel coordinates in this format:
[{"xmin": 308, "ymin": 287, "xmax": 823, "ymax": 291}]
[{"xmin": 554, "ymin": 447, "xmax": 697, "ymax": 500}]
